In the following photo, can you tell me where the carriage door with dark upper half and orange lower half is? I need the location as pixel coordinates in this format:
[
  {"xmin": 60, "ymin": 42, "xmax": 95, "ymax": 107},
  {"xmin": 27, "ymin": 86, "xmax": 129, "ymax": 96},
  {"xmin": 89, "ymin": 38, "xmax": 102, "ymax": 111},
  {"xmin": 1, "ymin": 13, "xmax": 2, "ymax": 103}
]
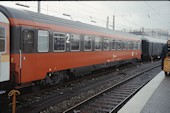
[{"xmin": 20, "ymin": 27, "xmax": 36, "ymax": 83}]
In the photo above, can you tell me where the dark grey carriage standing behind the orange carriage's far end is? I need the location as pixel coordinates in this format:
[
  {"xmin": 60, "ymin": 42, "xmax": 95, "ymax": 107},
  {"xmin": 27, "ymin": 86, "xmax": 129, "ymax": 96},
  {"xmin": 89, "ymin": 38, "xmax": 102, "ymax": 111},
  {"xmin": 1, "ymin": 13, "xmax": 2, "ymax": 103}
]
[{"xmin": 140, "ymin": 36, "xmax": 167, "ymax": 59}]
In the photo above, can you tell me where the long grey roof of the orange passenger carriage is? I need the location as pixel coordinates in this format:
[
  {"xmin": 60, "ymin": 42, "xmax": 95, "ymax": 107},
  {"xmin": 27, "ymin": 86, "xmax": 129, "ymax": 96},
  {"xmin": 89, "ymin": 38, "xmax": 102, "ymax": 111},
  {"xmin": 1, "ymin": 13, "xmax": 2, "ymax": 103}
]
[{"xmin": 0, "ymin": 5, "xmax": 140, "ymax": 40}]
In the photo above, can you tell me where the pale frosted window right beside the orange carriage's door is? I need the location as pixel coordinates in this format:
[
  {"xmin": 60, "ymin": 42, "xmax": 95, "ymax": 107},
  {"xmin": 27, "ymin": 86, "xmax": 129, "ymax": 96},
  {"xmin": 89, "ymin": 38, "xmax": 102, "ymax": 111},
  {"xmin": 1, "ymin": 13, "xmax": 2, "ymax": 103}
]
[{"xmin": 38, "ymin": 30, "xmax": 49, "ymax": 52}]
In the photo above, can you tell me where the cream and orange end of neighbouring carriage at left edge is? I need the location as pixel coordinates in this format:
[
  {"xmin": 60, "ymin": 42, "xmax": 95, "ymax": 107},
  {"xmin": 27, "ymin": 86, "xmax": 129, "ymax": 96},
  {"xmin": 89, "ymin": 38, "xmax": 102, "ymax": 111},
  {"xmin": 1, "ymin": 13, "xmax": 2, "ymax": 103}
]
[{"xmin": 0, "ymin": 12, "xmax": 10, "ymax": 82}]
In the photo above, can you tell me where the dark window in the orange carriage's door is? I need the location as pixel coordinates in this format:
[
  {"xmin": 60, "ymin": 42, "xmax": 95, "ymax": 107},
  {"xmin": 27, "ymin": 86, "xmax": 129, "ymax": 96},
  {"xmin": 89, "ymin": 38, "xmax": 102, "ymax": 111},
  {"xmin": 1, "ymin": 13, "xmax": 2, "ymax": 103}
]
[{"xmin": 23, "ymin": 30, "xmax": 34, "ymax": 52}]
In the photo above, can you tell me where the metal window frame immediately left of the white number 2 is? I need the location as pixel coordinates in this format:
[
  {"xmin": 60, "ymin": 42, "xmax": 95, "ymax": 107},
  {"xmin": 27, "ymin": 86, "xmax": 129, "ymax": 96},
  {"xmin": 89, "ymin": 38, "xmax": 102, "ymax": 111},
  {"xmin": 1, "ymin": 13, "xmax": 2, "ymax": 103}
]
[{"xmin": 53, "ymin": 32, "xmax": 67, "ymax": 52}]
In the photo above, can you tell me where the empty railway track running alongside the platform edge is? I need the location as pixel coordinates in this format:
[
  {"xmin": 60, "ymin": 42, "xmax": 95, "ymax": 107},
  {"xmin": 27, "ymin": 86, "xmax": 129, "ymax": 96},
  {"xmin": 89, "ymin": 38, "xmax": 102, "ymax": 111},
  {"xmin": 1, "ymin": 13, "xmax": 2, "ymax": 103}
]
[{"xmin": 63, "ymin": 65, "xmax": 160, "ymax": 113}]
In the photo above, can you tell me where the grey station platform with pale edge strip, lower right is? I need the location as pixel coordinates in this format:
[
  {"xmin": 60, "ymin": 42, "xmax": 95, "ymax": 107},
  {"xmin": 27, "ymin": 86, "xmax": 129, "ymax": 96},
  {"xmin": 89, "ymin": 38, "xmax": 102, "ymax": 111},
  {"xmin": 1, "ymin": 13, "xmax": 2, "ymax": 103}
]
[{"xmin": 118, "ymin": 71, "xmax": 170, "ymax": 113}]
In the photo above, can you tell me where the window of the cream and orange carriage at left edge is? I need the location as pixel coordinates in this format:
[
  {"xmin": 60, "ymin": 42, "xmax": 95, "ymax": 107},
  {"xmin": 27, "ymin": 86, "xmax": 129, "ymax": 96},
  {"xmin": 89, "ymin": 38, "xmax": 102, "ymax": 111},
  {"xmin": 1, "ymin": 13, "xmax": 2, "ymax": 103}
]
[{"xmin": 0, "ymin": 27, "xmax": 5, "ymax": 52}]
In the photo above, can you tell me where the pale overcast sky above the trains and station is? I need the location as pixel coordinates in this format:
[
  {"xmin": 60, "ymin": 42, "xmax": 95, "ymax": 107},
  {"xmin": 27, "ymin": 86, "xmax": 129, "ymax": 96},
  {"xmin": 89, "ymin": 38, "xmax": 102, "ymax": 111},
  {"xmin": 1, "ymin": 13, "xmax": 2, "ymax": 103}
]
[{"xmin": 0, "ymin": 1, "xmax": 170, "ymax": 32}]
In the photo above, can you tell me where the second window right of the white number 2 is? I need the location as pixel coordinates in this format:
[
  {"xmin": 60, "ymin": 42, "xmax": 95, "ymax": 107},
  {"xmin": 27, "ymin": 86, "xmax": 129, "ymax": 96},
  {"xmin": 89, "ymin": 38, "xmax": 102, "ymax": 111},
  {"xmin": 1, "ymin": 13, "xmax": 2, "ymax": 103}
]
[{"xmin": 84, "ymin": 36, "xmax": 92, "ymax": 51}]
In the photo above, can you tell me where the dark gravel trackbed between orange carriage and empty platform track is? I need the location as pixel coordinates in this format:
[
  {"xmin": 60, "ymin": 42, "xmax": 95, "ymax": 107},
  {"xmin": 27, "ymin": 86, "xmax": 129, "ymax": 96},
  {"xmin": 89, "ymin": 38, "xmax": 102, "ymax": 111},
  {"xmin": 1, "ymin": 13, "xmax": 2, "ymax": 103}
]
[{"xmin": 5, "ymin": 62, "xmax": 160, "ymax": 113}]
